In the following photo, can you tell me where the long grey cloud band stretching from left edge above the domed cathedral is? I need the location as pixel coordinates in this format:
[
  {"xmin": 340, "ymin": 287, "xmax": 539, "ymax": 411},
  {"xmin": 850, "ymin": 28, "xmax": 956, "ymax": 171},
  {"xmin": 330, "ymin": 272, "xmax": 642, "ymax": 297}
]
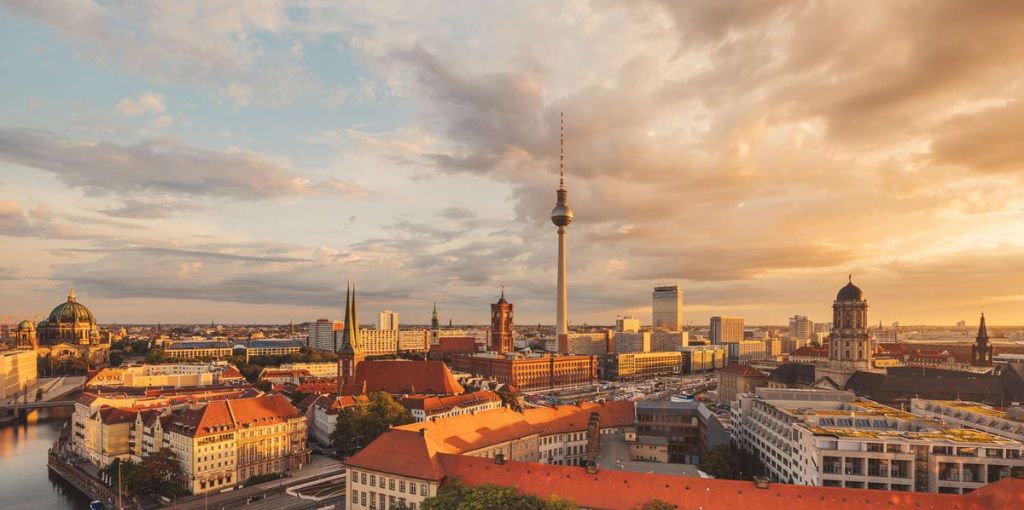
[{"xmin": 0, "ymin": 128, "xmax": 365, "ymax": 200}]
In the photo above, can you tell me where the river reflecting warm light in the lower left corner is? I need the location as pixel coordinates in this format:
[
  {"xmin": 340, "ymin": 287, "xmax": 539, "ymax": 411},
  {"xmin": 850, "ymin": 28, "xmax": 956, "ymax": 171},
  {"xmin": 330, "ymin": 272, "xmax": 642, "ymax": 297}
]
[{"xmin": 0, "ymin": 408, "xmax": 89, "ymax": 510}]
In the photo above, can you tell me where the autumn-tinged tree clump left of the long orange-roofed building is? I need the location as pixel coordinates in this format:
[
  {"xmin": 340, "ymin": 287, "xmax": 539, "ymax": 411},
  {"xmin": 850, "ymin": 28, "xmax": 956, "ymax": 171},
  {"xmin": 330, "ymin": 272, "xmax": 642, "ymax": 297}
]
[{"xmin": 331, "ymin": 391, "xmax": 414, "ymax": 458}]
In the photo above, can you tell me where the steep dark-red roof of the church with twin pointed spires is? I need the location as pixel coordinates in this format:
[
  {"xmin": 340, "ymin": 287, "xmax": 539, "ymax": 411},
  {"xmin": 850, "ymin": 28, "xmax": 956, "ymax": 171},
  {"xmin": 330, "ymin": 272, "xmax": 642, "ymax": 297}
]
[{"xmin": 342, "ymin": 359, "xmax": 466, "ymax": 395}]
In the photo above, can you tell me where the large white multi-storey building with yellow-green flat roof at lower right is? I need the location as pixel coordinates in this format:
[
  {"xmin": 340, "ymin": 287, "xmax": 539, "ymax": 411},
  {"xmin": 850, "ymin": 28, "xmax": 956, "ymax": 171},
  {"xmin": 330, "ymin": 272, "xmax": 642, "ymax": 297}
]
[{"xmin": 732, "ymin": 388, "xmax": 1024, "ymax": 494}]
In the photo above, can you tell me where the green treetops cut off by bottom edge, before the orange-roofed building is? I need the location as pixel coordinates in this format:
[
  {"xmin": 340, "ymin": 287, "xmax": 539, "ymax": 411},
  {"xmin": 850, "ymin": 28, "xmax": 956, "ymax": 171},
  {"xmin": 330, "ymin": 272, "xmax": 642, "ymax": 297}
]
[{"xmin": 422, "ymin": 480, "xmax": 579, "ymax": 510}]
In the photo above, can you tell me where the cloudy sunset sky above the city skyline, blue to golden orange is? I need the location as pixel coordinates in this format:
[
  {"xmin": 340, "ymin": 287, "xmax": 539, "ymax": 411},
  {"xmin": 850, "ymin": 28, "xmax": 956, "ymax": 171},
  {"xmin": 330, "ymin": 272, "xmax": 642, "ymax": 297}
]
[{"xmin": 0, "ymin": 0, "xmax": 1024, "ymax": 325}]
